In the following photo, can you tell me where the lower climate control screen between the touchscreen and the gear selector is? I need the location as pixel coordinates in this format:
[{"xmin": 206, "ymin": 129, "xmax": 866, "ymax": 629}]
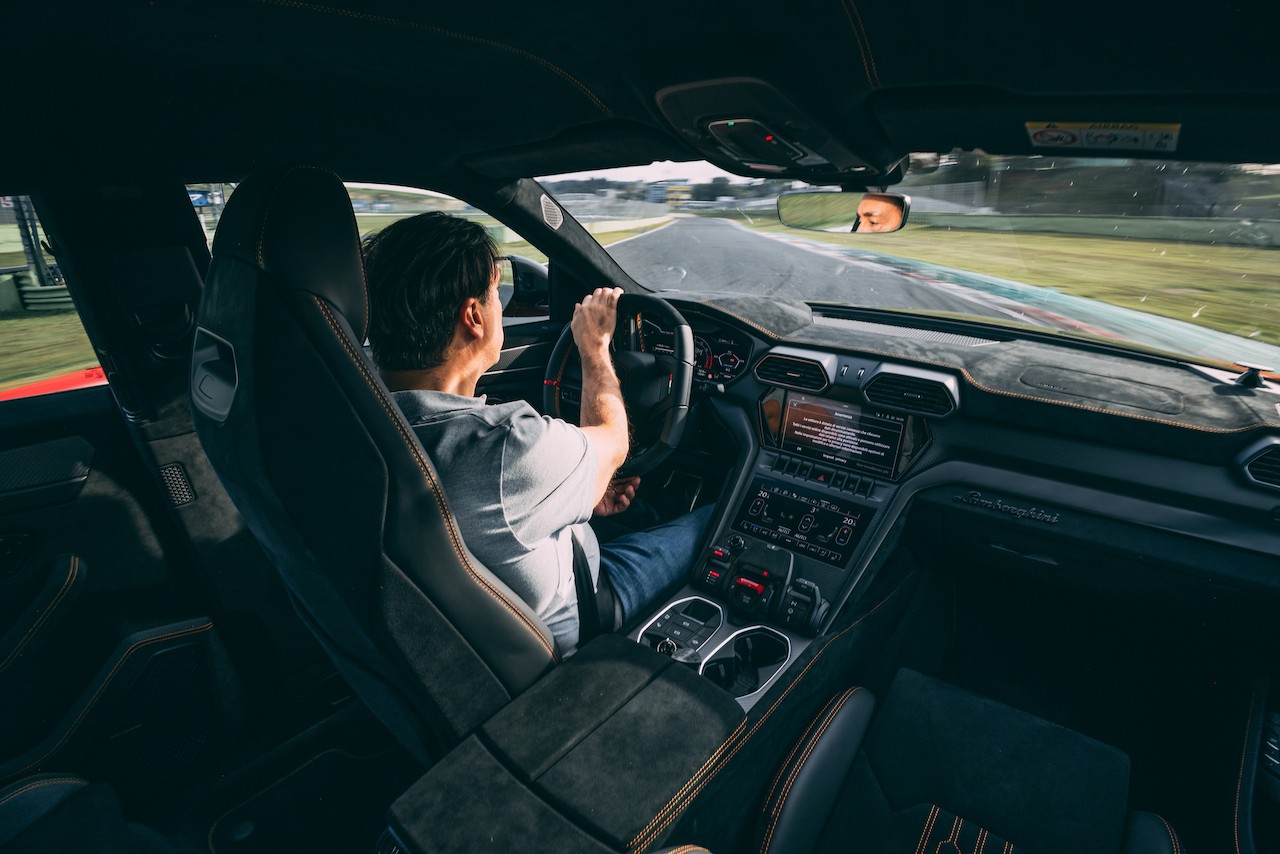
[{"xmin": 733, "ymin": 478, "xmax": 876, "ymax": 566}]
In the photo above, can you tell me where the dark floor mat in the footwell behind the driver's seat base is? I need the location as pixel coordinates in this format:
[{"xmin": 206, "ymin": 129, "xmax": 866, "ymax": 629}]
[{"xmin": 209, "ymin": 749, "xmax": 421, "ymax": 854}]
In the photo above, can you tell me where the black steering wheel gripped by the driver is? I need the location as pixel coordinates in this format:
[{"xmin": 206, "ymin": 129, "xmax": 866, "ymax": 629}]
[{"xmin": 543, "ymin": 293, "xmax": 694, "ymax": 478}]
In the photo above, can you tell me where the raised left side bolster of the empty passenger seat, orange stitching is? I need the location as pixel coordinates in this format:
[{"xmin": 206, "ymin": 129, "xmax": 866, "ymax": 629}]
[{"xmin": 759, "ymin": 688, "xmax": 876, "ymax": 851}]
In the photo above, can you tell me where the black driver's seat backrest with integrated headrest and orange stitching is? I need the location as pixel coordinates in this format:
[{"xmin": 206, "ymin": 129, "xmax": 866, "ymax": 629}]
[{"xmin": 191, "ymin": 166, "xmax": 557, "ymax": 758}]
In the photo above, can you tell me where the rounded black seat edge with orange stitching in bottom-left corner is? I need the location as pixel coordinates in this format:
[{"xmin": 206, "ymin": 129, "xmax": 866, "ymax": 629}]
[{"xmin": 0, "ymin": 773, "xmax": 175, "ymax": 854}]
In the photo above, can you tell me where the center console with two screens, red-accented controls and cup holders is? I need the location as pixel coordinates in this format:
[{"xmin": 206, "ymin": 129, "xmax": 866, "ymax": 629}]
[{"xmin": 635, "ymin": 389, "xmax": 929, "ymax": 708}]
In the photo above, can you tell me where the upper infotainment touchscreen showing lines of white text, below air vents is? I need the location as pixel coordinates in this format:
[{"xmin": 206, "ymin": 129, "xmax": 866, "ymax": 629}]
[{"xmin": 782, "ymin": 393, "xmax": 906, "ymax": 478}]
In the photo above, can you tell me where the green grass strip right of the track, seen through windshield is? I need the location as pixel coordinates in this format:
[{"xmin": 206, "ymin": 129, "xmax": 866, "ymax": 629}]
[{"xmin": 744, "ymin": 219, "xmax": 1280, "ymax": 344}]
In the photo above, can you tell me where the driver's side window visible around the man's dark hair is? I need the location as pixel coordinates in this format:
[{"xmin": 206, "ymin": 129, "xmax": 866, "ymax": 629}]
[{"xmin": 347, "ymin": 183, "xmax": 549, "ymax": 326}]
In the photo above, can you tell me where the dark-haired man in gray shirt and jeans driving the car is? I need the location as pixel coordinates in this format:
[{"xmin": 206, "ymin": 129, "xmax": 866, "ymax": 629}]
[{"xmin": 362, "ymin": 213, "xmax": 712, "ymax": 654}]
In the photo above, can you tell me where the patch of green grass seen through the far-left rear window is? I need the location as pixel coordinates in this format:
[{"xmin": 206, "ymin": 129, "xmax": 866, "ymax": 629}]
[{"xmin": 0, "ymin": 311, "xmax": 97, "ymax": 391}]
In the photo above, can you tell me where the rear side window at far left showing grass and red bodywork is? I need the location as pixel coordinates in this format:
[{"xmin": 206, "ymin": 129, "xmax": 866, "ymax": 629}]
[{"xmin": 0, "ymin": 196, "xmax": 106, "ymax": 401}]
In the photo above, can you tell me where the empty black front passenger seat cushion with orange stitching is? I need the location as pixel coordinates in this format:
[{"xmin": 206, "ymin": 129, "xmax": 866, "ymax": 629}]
[{"xmin": 759, "ymin": 670, "xmax": 1183, "ymax": 854}]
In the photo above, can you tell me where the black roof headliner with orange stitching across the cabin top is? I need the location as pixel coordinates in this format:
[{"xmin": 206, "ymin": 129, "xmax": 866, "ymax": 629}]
[{"xmin": 0, "ymin": 0, "xmax": 1280, "ymax": 189}]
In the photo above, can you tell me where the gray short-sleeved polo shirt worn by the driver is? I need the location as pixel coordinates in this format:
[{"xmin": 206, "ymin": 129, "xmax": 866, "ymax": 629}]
[{"xmin": 393, "ymin": 391, "xmax": 600, "ymax": 654}]
